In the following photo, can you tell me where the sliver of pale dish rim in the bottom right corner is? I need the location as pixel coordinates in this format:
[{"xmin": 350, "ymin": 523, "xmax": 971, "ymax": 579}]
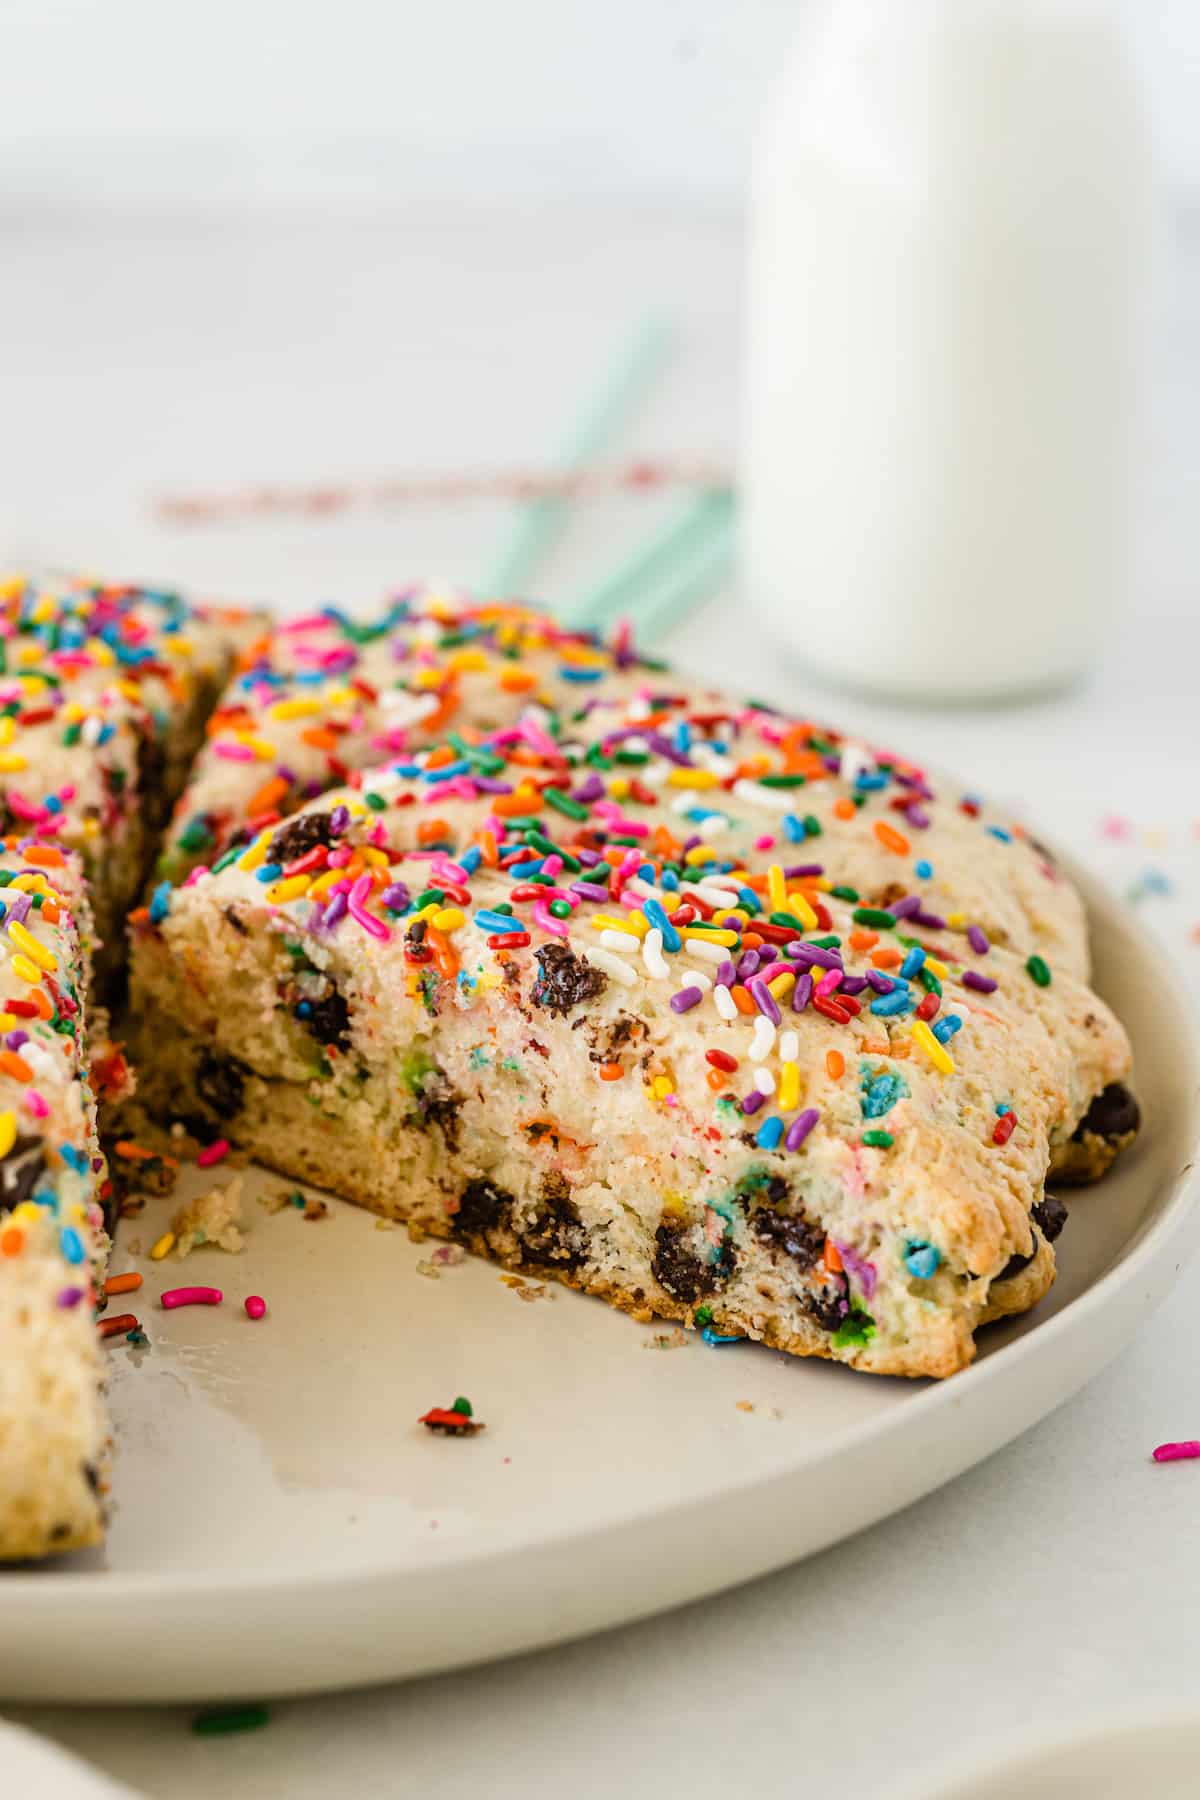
[{"xmin": 910, "ymin": 1717, "xmax": 1200, "ymax": 1800}]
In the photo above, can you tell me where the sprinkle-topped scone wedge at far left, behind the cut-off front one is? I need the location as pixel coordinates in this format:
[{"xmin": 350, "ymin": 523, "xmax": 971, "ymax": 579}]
[{"xmin": 0, "ymin": 574, "xmax": 260, "ymax": 972}]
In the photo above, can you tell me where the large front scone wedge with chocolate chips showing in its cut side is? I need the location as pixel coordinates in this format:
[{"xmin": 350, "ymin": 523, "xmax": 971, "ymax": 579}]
[{"xmin": 131, "ymin": 702, "xmax": 1128, "ymax": 1375}]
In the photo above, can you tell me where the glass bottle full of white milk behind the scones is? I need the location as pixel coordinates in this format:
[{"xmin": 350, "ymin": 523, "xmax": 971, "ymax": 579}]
[{"xmin": 743, "ymin": 0, "xmax": 1150, "ymax": 698}]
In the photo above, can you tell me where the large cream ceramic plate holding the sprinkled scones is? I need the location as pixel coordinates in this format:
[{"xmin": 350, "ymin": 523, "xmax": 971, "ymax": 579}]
[{"xmin": 0, "ymin": 860, "xmax": 1200, "ymax": 1701}]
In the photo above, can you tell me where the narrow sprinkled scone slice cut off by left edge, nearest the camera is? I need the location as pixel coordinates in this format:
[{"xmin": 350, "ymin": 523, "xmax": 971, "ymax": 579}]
[{"xmin": 0, "ymin": 839, "xmax": 108, "ymax": 1559}]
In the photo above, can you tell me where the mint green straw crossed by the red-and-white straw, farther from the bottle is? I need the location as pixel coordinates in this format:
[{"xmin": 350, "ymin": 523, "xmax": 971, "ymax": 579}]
[{"xmin": 482, "ymin": 315, "xmax": 675, "ymax": 599}]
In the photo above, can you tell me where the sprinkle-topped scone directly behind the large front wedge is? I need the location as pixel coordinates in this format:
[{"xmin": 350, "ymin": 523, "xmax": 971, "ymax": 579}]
[{"xmin": 150, "ymin": 590, "xmax": 1087, "ymax": 976}]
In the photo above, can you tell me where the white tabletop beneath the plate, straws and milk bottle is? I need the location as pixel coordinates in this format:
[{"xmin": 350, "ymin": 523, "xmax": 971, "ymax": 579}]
[{"xmin": 0, "ymin": 205, "xmax": 1200, "ymax": 1800}]
